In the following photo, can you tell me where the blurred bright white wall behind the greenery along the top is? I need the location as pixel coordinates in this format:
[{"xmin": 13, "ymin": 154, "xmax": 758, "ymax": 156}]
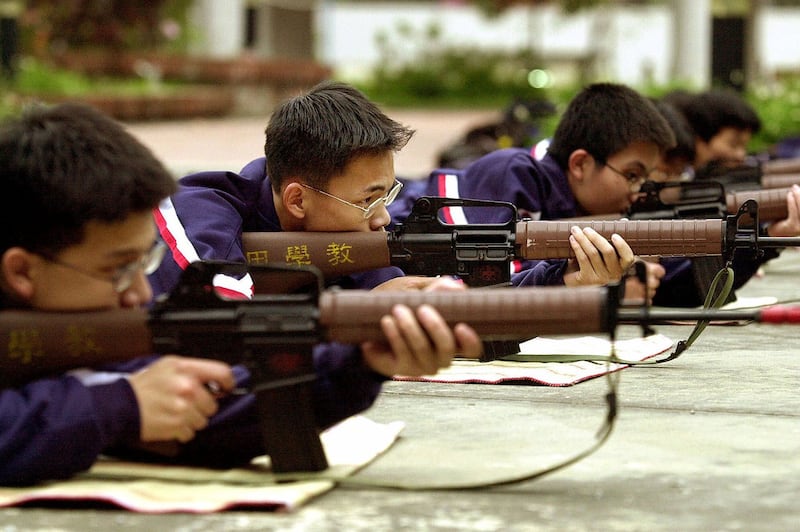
[{"xmin": 317, "ymin": 0, "xmax": 800, "ymax": 84}]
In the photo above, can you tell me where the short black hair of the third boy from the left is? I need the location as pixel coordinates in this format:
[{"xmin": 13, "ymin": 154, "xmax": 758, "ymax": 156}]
[{"xmin": 547, "ymin": 83, "xmax": 675, "ymax": 169}]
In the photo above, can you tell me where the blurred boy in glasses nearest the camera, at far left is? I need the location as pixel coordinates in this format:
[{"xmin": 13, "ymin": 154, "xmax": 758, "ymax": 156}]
[{"xmin": 0, "ymin": 104, "xmax": 480, "ymax": 485}]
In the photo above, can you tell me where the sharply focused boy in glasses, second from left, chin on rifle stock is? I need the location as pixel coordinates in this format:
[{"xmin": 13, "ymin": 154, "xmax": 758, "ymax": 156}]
[{"xmin": 150, "ymin": 82, "xmax": 446, "ymax": 297}]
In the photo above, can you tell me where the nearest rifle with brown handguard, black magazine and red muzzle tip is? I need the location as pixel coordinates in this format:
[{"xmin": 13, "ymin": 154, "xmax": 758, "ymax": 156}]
[{"xmin": 0, "ymin": 262, "xmax": 800, "ymax": 472}]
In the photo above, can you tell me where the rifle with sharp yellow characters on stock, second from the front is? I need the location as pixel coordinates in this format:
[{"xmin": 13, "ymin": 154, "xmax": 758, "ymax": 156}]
[{"xmin": 242, "ymin": 197, "xmax": 800, "ymax": 286}]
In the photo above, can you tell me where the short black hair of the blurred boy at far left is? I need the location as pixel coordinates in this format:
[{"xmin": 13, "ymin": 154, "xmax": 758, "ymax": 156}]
[{"xmin": 0, "ymin": 102, "xmax": 176, "ymax": 254}]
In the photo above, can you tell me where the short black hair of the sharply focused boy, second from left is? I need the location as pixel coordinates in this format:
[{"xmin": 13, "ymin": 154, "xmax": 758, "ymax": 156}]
[{"xmin": 264, "ymin": 81, "xmax": 414, "ymax": 190}]
